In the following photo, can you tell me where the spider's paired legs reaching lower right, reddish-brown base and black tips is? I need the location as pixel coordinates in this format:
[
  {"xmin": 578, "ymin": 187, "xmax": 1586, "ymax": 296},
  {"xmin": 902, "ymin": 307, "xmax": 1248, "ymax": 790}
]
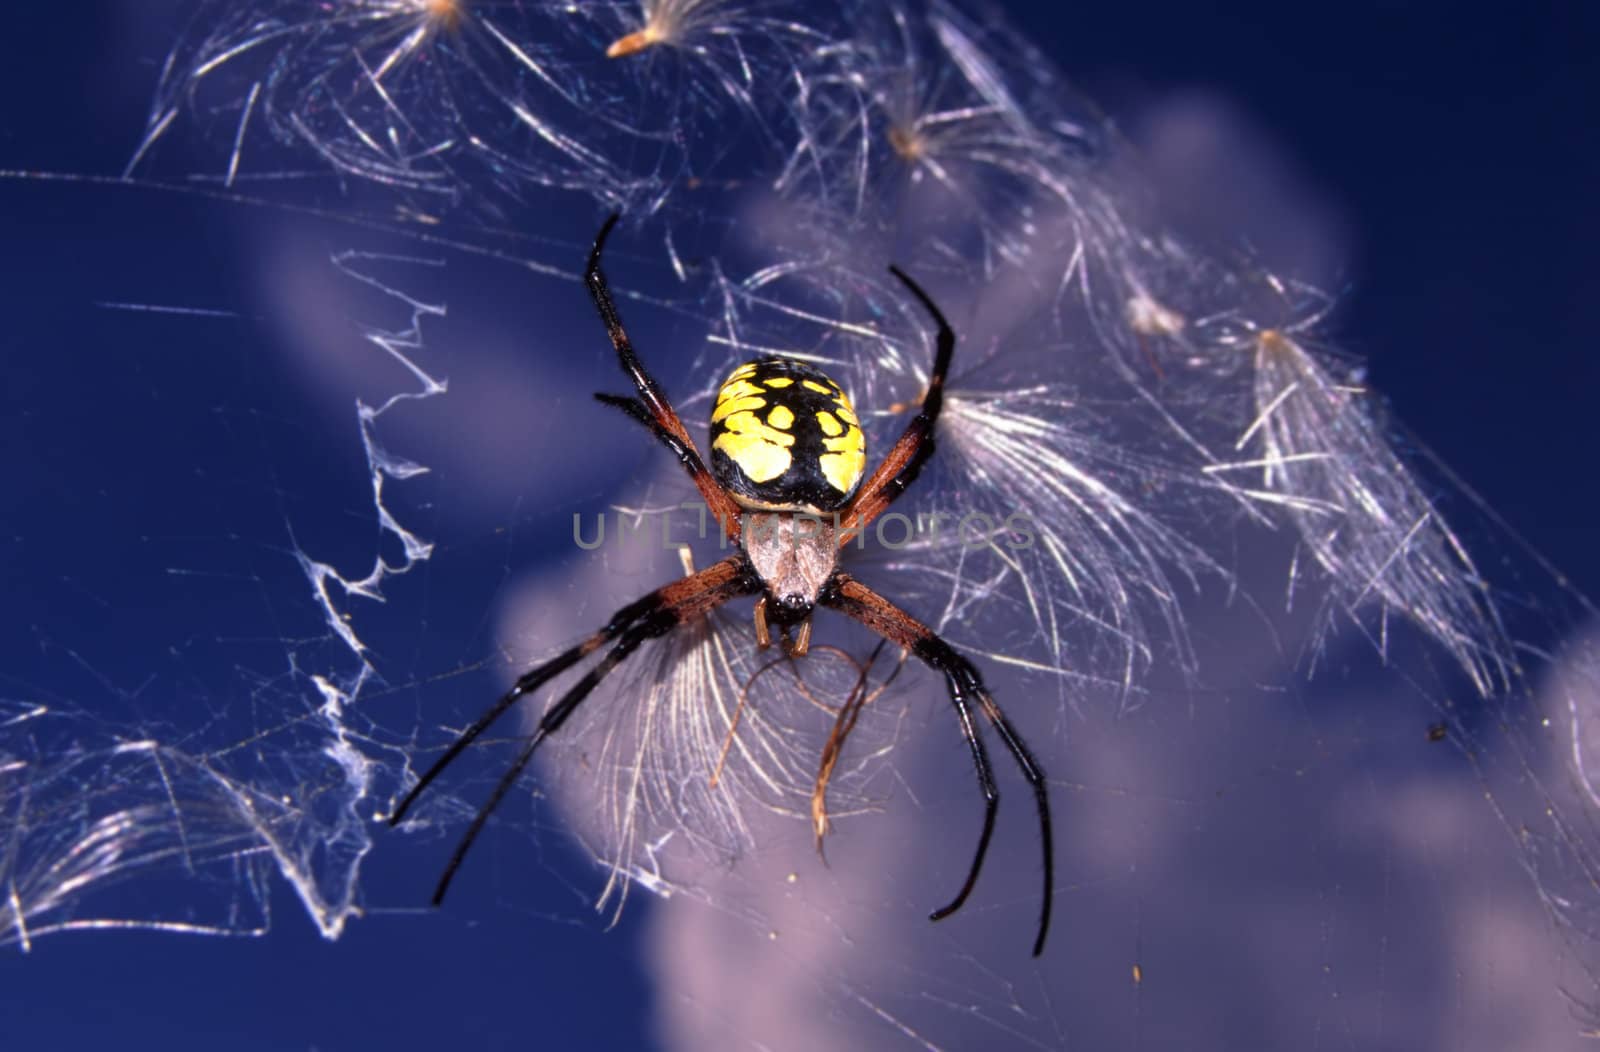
[{"xmin": 819, "ymin": 572, "xmax": 1056, "ymax": 958}]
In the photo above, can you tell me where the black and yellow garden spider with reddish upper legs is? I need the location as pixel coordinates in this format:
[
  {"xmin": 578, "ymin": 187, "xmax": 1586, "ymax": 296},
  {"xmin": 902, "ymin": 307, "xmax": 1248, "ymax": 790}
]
[{"xmin": 389, "ymin": 213, "xmax": 1054, "ymax": 956}]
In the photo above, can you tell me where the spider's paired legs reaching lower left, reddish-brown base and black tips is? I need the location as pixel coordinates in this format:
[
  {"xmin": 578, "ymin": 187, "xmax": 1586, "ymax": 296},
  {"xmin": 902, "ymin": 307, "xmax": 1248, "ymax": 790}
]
[{"xmin": 389, "ymin": 553, "xmax": 760, "ymax": 905}]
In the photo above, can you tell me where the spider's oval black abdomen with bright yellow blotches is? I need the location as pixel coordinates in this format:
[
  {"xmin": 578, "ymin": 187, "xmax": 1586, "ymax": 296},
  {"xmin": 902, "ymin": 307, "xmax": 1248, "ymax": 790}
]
[{"xmin": 710, "ymin": 357, "xmax": 867, "ymax": 512}]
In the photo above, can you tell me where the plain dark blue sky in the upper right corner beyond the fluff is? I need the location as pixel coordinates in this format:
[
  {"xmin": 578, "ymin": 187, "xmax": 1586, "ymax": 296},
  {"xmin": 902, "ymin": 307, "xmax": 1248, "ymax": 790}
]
[{"xmin": 1036, "ymin": 3, "xmax": 1600, "ymax": 593}]
